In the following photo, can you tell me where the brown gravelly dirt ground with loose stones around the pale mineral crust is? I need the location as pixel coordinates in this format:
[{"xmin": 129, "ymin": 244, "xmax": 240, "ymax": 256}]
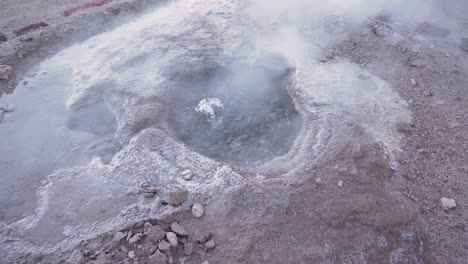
[{"xmin": 0, "ymin": 0, "xmax": 468, "ymax": 264}]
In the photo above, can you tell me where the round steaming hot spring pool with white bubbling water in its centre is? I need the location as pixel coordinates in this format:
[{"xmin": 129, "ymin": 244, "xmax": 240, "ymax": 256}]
[{"xmin": 170, "ymin": 56, "xmax": 301, "ymax": 166}]
